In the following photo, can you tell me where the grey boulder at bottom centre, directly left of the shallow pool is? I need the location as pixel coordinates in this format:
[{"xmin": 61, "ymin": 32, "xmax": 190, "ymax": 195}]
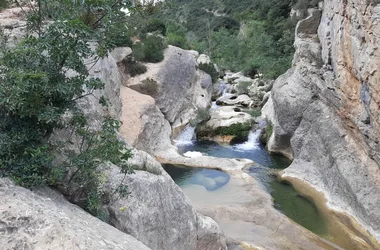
[{"xmin": 104, "ymin": 158, "xmax": 226, "ymax": 250}]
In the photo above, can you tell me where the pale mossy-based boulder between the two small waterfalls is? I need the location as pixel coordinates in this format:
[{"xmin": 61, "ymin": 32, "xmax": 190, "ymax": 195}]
[{"xmin": 195, "ymin": 106, "xmax": 253, "ymax": 143}]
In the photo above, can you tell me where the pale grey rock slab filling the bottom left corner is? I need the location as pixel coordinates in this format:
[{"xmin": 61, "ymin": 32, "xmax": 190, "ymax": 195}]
[{"xmin": 0, "ymin": 178, "xmax": 149, "ymax": 250}]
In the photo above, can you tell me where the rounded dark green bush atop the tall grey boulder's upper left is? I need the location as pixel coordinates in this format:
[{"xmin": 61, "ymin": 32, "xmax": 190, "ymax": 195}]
[{"xmin": 132, "ymin": 35, "xmax": 167, "ymax": 63}]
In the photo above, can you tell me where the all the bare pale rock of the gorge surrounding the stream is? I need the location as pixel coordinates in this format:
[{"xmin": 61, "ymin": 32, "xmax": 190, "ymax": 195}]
[{"xmin": 0, "ymin": 0, "xmax": 380, "ymax": 250}]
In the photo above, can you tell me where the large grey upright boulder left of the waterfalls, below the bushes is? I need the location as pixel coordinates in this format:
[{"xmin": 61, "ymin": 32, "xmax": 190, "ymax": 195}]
[{"xmin": 125, "ymin": 46, "xmax": 212, "ymax": 130}]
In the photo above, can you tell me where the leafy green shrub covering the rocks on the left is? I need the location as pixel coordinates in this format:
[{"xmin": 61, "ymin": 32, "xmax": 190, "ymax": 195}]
[{"xmin": 0, "ymin": 0, "xmax": 137, "ymax": 214}]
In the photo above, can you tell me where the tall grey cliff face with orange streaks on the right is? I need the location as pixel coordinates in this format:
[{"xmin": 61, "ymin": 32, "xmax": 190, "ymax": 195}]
[{"xmin": 263, "ymin": 0, "xmax": 380, "ymax": 242}]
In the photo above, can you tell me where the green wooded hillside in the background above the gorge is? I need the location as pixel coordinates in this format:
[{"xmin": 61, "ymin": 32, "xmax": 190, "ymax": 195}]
[{"xmin": 152, "ymin": 0, "xmax": 318, "ymax": 78}]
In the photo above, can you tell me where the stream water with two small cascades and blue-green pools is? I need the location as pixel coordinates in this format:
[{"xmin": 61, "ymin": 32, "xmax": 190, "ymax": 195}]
[{"xmin": 172, "ymin": 127, "xmax": 328, "ymax": 237}]
